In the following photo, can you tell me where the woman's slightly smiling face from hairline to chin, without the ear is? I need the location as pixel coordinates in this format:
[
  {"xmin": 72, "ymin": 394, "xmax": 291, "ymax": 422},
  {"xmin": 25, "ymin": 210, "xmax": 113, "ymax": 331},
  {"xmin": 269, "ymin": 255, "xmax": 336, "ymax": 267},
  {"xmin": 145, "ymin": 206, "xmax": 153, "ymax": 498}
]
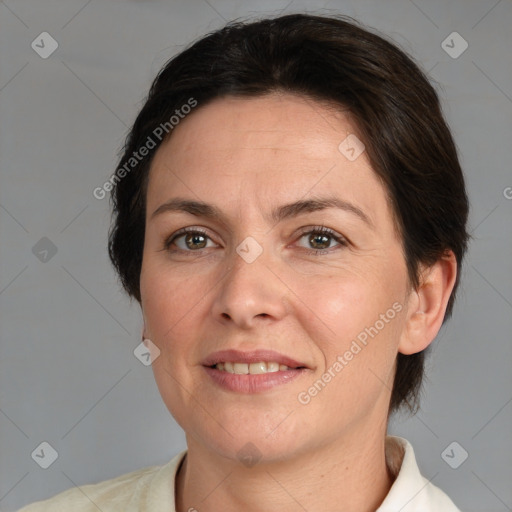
[{"xmin": 140, "ymin": 94, "xmax": 408, "ymax": 460}]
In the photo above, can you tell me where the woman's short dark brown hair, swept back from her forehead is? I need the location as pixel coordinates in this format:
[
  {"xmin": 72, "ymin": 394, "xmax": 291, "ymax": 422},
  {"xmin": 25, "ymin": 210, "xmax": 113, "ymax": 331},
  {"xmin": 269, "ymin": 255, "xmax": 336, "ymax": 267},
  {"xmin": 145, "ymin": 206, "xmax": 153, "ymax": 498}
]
[{"xmin": 109, "ymin": 14, "xmax": 469, "ymax": 413}]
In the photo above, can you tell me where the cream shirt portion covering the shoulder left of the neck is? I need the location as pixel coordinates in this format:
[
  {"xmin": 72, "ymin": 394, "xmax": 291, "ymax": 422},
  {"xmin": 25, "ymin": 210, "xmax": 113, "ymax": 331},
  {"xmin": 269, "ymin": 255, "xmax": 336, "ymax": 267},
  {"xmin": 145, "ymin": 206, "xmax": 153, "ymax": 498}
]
[{"xmin": 18, "ymin": 452, "xmax": 186, "ymax": 512}]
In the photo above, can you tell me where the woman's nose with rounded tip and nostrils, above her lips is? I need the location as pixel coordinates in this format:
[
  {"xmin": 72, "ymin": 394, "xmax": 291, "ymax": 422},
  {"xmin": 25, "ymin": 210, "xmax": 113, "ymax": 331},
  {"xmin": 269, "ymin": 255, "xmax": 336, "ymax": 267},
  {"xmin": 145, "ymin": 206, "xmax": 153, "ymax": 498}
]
[{"xmin": 212, "ymin": 246, "xmax": 289, "ymax": 329}]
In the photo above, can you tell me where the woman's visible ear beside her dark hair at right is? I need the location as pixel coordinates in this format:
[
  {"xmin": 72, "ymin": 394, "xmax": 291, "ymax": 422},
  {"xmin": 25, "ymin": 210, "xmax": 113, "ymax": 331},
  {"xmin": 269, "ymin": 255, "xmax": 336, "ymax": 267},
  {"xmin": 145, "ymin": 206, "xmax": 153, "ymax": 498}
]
[{"xmin": 398, "ymin": 251, "xmax": 457, "ymax": 355}]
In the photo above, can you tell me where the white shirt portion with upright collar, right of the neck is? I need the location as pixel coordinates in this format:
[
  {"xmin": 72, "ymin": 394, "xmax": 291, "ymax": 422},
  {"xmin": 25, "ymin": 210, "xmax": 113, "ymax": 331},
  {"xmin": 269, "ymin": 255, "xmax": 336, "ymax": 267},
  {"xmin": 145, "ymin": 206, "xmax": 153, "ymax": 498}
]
[{"xmin": 378, "ymin": 436, "xmax": 460, "ymax": 512}]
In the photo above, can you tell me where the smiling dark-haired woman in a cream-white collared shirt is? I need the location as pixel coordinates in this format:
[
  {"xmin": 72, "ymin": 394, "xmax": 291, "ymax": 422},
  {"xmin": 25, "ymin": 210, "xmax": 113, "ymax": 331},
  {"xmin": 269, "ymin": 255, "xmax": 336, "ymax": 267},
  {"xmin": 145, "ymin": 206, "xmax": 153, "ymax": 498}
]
[{"xmin": 22, "ymin": 15, "xmax": 468, "ymax": 512}]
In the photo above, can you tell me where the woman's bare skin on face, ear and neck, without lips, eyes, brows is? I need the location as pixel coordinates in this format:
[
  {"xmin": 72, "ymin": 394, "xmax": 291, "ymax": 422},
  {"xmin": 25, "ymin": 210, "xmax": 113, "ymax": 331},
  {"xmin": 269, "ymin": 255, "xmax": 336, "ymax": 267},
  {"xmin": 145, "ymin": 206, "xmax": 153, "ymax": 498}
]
[{"xmin": 140, "ymin": 93, "xmax": 456, "ymax": 512}]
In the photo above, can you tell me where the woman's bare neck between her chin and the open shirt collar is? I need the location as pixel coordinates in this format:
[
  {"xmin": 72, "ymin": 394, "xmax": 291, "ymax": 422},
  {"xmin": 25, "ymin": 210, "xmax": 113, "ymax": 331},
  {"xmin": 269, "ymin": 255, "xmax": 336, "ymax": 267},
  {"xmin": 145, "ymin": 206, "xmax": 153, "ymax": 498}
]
[{"xmin": 176, "ymin": 422, "xmax": 394, "ymax": 512}]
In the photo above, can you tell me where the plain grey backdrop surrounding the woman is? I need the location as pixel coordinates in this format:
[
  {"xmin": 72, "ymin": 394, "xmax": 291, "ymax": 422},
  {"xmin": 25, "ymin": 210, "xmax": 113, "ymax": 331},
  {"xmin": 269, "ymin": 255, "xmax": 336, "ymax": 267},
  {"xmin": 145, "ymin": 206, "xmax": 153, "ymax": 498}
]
[{"xmin": 0, "ymin": 0, "xmax": 512, "ymax": 512}]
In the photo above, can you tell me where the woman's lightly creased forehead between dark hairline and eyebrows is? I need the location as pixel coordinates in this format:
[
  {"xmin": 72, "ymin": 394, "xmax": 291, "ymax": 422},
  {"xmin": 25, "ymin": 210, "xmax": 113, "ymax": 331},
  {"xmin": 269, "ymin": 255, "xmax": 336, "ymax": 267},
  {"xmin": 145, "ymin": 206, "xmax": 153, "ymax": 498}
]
[{"xmin": 147, "ymin": 94, "xmax": 390, "ymax": 233}]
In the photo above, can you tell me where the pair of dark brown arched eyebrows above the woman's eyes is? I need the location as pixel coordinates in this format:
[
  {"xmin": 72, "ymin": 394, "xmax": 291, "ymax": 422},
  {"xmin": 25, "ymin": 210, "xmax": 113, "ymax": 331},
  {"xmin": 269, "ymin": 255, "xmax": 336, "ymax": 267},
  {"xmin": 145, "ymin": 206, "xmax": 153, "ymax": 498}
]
[{"xmin": 151, "ymin": 197, "xmax": 374, "ymax": 229}]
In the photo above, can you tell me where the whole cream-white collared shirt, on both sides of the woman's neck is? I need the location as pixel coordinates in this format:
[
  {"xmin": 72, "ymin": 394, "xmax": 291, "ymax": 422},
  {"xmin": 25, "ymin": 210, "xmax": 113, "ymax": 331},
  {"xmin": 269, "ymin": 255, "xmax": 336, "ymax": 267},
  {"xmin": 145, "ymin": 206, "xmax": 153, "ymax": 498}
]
[{"xmin": 18, "ymin": 436, "xmax": 460, "ymax": 512}]
